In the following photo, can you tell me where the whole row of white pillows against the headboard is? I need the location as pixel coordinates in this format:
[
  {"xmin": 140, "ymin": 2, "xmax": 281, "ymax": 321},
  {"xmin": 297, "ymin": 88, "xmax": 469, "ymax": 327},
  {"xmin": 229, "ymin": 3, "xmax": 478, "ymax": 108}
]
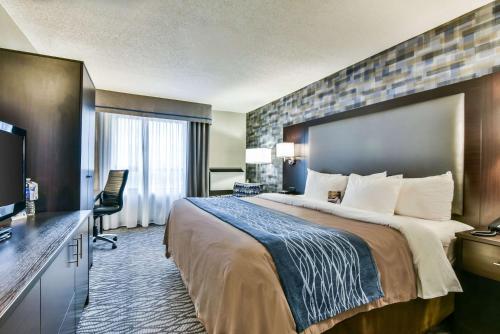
[{"xmin": 304, "ymin": 169, "xmax": 454, "ymax": 220}]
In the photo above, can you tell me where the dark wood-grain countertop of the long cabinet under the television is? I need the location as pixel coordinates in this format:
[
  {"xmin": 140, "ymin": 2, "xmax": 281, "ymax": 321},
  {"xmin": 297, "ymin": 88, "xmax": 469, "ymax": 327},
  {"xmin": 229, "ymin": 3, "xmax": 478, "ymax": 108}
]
[{"xmin": 0, "ymin": 211, "xmax": 91, "ymax": 318}]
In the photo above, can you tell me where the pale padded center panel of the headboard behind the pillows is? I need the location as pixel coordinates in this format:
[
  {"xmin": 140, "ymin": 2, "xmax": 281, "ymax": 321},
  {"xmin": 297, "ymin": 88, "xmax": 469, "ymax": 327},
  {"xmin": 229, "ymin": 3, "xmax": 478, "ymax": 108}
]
[{"xmin": 309, "ymin": 93, "xmax": 465, "ymax": 215}]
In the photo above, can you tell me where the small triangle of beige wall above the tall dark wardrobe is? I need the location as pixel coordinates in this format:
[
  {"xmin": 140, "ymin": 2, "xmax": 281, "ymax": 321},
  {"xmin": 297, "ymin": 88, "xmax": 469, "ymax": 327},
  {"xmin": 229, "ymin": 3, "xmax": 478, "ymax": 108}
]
[{"xmin": 0, "ymin": 5, "xmax": 36, "ymax": 52}]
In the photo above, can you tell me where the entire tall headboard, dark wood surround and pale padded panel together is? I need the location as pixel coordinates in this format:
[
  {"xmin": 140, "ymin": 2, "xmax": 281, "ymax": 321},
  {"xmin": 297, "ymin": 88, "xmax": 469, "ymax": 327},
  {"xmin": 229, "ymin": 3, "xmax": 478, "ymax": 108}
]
[{"xmin": 283, "ymin": 73, "xmax": 500, "ymax": 226}]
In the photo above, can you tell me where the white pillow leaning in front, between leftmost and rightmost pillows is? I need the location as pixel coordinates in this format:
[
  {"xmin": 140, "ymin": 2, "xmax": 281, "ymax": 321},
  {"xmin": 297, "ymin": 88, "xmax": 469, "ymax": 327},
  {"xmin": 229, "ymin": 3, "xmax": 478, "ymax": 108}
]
[{"xmin": 341, "ymin": 174, "xmax": 402, "ymax": 215}]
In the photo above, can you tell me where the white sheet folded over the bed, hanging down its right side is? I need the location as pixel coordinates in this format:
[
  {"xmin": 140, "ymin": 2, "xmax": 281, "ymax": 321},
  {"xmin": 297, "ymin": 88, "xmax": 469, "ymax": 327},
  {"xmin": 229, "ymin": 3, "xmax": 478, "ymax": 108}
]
[{"xmin": 259, "ymin": 194, "xmax": 472, "ymax": 299}]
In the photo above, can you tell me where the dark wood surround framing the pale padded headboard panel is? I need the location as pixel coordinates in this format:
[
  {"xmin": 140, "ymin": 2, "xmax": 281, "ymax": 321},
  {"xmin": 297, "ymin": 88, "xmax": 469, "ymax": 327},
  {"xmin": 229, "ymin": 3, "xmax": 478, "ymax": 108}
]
[{"xmin": 283, "ymin": 73, "xmax": 500, "ymax": 230}]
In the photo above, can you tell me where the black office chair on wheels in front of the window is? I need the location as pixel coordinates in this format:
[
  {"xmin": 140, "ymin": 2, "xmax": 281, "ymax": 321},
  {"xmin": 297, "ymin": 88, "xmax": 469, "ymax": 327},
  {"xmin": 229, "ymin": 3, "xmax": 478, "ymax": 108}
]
[{"xmin": 93, "ymin": 169, "xmax": 128, "ymax": 249}]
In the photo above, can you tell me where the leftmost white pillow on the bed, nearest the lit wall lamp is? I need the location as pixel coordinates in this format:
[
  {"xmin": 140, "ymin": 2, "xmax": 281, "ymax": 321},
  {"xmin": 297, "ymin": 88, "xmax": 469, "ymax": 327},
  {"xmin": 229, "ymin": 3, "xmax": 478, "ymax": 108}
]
[{"xmin": 304, "ymin": 168, "xmax": 347, "ymax": 202}]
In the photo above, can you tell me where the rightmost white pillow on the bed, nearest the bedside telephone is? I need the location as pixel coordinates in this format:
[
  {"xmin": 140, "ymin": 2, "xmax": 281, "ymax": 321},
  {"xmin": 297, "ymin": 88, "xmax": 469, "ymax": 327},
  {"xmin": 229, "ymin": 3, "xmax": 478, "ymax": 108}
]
[{"xmin": 396, "ymin": 172, "xmax": 453, "ymax": 220}]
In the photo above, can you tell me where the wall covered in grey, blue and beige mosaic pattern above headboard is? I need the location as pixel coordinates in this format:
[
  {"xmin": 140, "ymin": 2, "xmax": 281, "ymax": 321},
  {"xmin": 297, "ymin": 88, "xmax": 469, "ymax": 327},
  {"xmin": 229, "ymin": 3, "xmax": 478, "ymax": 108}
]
[{"xmin": 247, "ymin": 0, "xmax": 500, "ymax": 191}]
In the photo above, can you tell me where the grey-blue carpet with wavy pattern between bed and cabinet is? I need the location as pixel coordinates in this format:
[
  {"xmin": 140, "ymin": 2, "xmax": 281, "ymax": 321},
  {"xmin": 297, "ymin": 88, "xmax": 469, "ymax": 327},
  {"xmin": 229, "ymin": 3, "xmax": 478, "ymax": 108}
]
[{"xmin": 78, "ymin": 225, "xmax": 205, "ymax": 334}]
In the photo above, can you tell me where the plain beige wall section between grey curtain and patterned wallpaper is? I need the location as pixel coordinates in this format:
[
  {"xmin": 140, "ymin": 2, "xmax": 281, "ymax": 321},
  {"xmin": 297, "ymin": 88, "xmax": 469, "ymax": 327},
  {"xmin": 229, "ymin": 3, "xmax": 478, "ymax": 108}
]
[{"xmin": 208, "ymin": 110, "xmax": 246, "ymax": 169}]
